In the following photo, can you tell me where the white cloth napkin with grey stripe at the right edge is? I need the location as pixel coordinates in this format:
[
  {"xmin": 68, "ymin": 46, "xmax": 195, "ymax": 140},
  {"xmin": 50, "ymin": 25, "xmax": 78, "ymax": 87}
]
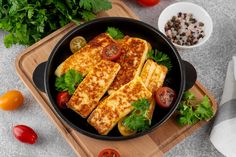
[{"xmin": 210, "ymin": 56, "xmax": 236, "ymax": 157}]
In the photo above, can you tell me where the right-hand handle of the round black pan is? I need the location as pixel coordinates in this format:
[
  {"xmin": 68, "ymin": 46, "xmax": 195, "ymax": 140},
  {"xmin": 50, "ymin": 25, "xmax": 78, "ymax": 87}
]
[{"xmin": 182, "ymin": 60, "xmax": 197, "ymax": 91}]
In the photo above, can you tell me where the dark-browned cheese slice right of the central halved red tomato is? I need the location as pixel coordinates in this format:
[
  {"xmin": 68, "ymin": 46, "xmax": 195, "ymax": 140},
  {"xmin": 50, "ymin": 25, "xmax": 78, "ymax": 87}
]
[{"xmin": 108, "ymin": 36, "xmax": 148, "ymax": 94}]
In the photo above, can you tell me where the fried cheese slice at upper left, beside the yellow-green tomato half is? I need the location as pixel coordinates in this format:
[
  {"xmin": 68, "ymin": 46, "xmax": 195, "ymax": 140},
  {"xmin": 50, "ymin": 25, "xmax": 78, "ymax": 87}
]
[{"xmin": 55, "ymin": 33, "xmax": 115, "ymax": 77}]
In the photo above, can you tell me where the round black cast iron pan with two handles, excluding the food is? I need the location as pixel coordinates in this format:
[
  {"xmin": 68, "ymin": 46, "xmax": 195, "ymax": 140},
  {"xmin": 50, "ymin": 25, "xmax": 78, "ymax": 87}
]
[{"xmin": 33, "ymin": 17, "xmax": 196, "ymax": 140}]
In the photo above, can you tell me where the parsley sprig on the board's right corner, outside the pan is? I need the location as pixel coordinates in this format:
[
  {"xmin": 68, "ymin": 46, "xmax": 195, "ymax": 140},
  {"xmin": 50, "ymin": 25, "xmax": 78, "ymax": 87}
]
[{"xmin": 177, "ymin": 91, "xmax": 213, "ymax": 126}]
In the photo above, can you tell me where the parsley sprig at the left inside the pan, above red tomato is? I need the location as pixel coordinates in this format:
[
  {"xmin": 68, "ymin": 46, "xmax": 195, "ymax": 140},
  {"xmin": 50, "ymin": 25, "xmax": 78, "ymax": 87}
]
[{"xmin": 55, "ymin": 69, "xmax": 83, "ymax": 95}]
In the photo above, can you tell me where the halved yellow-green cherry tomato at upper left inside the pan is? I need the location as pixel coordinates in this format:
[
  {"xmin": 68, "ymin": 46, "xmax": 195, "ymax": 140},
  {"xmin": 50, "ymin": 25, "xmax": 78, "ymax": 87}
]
[{"xmin": 70, "ymin": 36, "xmax": 87, "ymax": 53}]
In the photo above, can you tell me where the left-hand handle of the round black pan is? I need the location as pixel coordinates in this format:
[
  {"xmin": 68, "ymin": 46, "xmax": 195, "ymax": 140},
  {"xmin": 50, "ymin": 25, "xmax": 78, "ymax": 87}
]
[{"xmin": 33, "ymin": 62, "xmax": 47, "ymax": 93}]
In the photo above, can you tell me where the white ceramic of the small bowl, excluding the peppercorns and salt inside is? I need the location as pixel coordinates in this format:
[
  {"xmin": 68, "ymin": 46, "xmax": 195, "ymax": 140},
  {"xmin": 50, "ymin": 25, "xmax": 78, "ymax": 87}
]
[{"xmin": 158, "ymin": 2, "xmax": 213, "ymax": 48}]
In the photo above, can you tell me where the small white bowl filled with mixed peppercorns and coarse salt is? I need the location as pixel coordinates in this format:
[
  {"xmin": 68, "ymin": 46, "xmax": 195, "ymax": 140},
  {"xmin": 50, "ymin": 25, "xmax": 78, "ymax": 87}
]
[{"xmin": 158, "ymin": 2, "xmax": 213, "ymax": 48}]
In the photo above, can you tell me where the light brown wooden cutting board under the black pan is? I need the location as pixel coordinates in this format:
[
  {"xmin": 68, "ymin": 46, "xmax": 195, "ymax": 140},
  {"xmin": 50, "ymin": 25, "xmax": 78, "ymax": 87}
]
[{"xmin": 16, "ymin": 1, "xmax": 217, "ymax": 157}]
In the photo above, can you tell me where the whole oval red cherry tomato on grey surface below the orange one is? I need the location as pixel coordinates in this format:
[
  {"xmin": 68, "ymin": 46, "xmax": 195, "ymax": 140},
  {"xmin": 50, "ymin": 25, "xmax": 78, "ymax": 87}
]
[{"xmin": 13, "ymin": 125, "xmax": 38, "ymax": 144}]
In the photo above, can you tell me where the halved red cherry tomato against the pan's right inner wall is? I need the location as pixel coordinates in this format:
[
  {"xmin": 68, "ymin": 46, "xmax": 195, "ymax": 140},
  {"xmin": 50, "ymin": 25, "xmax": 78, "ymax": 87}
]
[{"xmin": 154, "ymin": 87, "xmax": 176, "ymax": 108}]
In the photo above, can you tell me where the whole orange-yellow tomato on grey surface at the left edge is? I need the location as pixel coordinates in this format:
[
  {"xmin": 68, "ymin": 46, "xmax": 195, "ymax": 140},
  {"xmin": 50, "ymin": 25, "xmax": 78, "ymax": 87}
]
[{"xmin": 0, "ymin": 90, "xmax": 24, "ymax": 111}]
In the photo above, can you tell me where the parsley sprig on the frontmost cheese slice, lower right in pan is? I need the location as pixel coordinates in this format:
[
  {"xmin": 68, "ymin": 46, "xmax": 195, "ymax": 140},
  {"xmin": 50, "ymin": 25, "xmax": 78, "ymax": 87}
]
[{"xmin": 123, "ymin": 99, "xmax": 151, "ymax": 131}]
